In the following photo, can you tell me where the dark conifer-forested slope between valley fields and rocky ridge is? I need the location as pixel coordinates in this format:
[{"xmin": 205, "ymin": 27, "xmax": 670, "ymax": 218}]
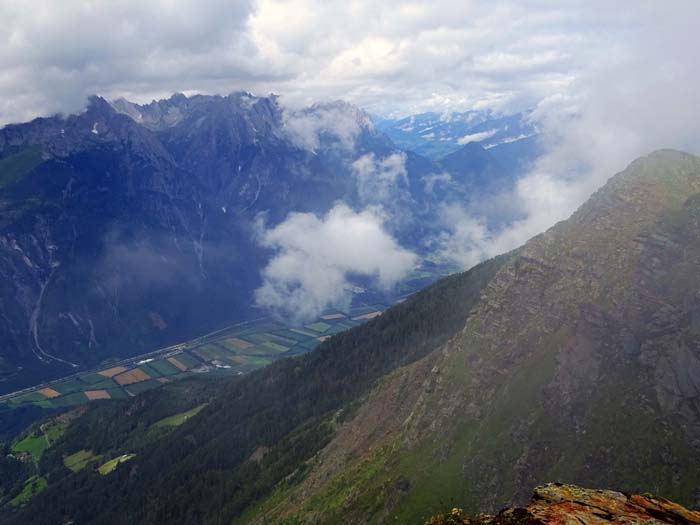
[{"xmin": 5, "ymin": 252, "xmax": 509, "ymax": 524}]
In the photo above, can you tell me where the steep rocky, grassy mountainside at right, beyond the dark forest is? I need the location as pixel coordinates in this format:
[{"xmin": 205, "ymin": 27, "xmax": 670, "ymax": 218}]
[{"xmin": 255, "ymin": 151, "xmax": 700, "ymax": 523}]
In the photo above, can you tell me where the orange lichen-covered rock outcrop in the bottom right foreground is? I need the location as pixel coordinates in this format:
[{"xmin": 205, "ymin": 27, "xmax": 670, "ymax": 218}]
[{"xmin": 426, "ymin": 484, "xmax": 700, "ymax": 525}]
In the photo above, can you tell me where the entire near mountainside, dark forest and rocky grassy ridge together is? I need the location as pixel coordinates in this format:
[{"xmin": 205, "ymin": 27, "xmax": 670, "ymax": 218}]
[{"xmin": 0, "ymin": 150, "xmax": 700, "ymax": 524}]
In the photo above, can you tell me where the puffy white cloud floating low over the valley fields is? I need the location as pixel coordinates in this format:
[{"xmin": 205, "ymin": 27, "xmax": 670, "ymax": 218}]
[{"xmin": 255, "ymin": 203, "xmax": 417, "ymax": 321}]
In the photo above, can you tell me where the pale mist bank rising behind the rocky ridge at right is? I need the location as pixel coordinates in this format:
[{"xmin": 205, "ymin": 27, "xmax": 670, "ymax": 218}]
[{"xmin": 440, "ymin": 2, "xmax": 700, "ymax": 266}]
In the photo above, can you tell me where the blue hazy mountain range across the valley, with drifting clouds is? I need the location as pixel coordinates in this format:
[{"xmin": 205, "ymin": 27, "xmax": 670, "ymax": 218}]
[{"xmin": 0, "ymin": 92, "xmax": 532, "ymax": 391}]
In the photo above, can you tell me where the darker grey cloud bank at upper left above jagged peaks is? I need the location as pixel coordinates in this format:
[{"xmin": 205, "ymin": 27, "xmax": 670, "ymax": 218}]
[{"xmin": 0, "ymin": 0, "xmax": 262, "ymax": 124}]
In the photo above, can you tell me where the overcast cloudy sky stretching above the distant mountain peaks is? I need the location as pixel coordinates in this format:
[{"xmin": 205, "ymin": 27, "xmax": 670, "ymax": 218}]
[{"xmin": 0, "ymin": 0, "xmax": 700, "ymax": 124}]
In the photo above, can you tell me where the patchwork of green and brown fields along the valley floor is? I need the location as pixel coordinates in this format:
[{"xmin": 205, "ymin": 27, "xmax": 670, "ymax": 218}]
[{"xmin": 0, "ymin": 304, "xmax": 394, "ymax": 414}]
